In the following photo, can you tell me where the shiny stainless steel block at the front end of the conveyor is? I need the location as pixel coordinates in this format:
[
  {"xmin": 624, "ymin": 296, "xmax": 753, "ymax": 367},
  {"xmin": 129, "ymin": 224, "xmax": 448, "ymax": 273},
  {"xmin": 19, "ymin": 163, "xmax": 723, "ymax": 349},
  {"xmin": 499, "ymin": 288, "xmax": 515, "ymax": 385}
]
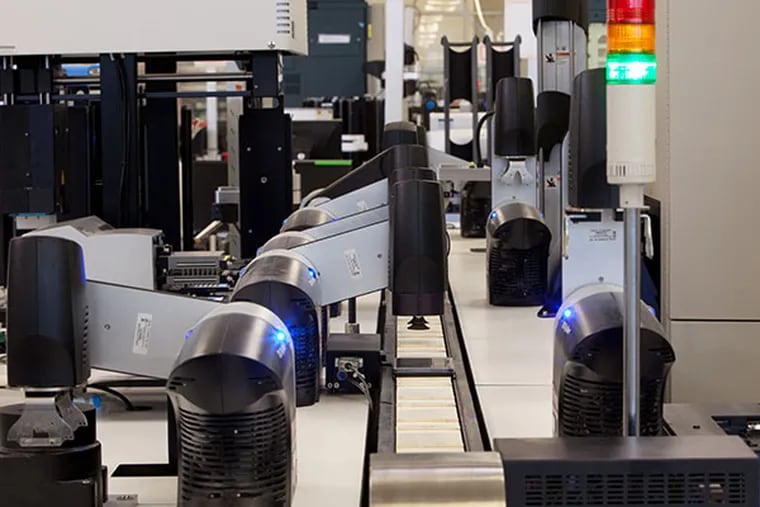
[{"xmin": 369, "ymin": 452, "xmax": 506, "ymax": 507}]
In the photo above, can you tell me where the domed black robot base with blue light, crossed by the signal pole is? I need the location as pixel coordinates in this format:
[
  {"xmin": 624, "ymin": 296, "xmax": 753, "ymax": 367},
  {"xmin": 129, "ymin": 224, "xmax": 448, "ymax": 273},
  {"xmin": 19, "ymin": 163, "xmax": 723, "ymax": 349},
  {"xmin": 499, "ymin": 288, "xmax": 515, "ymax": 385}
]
[{"xmin": 554, "ymin": 286, "xmax": 675, "ymax": 437}]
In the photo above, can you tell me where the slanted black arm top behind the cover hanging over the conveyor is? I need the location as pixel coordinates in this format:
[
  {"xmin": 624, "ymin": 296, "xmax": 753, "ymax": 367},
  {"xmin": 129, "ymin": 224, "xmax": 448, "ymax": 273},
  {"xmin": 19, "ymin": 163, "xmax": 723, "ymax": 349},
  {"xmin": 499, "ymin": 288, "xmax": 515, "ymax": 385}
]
[{"xmin": 317, "ymin": 144, "xmax": 428, "ymax": 199}]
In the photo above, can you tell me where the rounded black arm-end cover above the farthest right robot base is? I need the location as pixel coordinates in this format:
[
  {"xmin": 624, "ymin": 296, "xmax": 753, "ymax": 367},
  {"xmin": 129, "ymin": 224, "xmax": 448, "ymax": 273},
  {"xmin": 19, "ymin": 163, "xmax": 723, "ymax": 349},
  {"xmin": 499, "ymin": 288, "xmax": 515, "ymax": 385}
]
[{"xmin": 493, "ymin": 77, "xmax": 536, "ymax": 157}]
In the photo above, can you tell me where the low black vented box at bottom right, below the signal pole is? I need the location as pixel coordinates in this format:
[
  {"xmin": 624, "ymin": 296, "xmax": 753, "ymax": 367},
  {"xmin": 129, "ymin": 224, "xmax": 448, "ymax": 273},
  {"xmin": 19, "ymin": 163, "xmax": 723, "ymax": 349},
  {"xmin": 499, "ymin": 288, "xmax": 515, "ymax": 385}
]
[{"xmin": 494, "ymin": 436, "xmax": 760, "ymax": 507}]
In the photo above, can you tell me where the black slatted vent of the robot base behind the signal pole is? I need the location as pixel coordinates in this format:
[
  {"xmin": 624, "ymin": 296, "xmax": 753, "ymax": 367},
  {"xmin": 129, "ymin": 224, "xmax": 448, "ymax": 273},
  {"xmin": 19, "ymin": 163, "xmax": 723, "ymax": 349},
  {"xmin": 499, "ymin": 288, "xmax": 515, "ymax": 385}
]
[{"xmin": 559, "ymin": 375, "xmax": 663, "ymax": 437}]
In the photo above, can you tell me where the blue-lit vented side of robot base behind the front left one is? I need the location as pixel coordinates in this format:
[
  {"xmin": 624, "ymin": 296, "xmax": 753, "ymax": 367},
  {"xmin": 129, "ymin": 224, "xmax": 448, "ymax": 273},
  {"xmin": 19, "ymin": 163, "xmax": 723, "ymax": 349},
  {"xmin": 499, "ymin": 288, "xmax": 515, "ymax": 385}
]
[{"xmin": 287, "ymin": 299, "xmax": 320, "ymax": 407}]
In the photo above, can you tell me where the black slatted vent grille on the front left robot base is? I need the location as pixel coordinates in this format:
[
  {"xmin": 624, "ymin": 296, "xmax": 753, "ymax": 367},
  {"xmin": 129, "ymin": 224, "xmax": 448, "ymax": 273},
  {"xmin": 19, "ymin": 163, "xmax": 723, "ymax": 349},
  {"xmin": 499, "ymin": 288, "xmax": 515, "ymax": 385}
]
[{"xmin": 178, "ymin": 404, "xmax": 292, "ymax": 505}]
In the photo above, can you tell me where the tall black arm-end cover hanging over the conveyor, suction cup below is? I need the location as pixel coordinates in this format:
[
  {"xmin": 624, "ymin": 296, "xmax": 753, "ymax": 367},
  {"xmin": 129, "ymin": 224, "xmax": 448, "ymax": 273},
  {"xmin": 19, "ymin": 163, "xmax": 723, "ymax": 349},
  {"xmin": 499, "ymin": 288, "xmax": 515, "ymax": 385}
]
[{"xmin": 391, "ymin": 180, "xmax": 448, "ymax": 316}]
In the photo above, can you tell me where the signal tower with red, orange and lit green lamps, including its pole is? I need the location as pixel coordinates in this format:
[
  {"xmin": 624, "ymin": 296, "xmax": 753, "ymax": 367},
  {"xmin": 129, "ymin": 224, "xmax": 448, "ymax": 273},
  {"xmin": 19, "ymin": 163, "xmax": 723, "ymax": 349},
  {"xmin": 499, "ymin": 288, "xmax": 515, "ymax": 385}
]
[{"xmin": 607, "ymin": 0, "xmax": 657, "ymax": 436}]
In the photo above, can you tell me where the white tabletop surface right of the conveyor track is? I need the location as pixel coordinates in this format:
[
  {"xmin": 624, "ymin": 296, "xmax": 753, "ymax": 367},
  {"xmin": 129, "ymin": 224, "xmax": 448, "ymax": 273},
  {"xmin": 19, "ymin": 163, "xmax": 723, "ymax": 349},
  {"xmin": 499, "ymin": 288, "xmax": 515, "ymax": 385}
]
[{"xmin": 449, "ymin": 230, "xmax": 554, "ymax": 440}]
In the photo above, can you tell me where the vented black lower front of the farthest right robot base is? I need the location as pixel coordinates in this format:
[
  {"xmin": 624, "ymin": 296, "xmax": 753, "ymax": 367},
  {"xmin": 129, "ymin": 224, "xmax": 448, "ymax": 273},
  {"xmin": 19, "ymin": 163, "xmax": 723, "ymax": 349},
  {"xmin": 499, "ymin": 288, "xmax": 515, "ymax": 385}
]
[{"xmin": 488, "ymin": 239, "xmax": 549, "ymax": 305}]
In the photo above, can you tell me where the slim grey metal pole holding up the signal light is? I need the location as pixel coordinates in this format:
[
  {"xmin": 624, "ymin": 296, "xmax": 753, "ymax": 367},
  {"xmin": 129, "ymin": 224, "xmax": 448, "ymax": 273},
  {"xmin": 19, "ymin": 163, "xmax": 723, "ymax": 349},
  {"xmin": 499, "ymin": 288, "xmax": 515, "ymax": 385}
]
[{"xmin": 623, "ymin": 208, "xmax": 641, "ymax": 437}]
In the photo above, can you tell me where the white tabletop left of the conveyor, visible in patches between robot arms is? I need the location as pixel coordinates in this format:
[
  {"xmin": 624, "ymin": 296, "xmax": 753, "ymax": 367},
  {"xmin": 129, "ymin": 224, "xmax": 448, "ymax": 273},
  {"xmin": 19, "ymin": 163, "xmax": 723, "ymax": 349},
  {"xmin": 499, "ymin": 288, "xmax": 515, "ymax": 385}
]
[{"xmin": 0, "ymin": 295, "xmax": 380, "ymax": 507}]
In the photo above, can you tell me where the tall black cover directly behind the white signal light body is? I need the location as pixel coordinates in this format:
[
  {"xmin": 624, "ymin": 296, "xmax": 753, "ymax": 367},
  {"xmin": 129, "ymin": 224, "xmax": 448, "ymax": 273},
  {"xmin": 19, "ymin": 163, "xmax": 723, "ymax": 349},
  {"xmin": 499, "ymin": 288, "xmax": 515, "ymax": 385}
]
[{"xmin": 568, "ymin": 69, "xmax": 619, "ymax": 209}]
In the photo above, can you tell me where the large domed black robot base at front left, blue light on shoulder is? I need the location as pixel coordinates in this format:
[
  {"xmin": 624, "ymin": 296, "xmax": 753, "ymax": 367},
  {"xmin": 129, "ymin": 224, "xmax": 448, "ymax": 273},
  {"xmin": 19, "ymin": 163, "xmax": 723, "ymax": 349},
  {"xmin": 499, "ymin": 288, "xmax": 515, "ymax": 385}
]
[{"xmin": 167, "ymin": 303, "xmax": 295, "ymax": 507}]
